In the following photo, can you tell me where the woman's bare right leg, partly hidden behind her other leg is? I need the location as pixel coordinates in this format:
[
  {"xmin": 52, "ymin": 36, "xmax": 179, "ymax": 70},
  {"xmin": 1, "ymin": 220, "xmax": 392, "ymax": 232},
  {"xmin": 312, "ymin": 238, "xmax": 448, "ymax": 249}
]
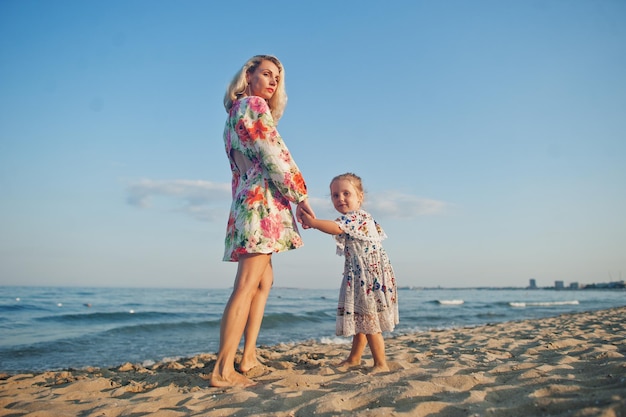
[{"xmin": 239, "ymin": 261, "xmax": 274, "ymax": 372}]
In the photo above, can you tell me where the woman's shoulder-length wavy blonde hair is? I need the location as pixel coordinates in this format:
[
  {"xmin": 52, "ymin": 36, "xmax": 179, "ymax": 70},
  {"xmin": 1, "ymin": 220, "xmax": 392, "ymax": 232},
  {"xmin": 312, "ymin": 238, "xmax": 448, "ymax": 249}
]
[{"xmin": 224, "ymin": 55, "xmax": 287, "ymax": 124}]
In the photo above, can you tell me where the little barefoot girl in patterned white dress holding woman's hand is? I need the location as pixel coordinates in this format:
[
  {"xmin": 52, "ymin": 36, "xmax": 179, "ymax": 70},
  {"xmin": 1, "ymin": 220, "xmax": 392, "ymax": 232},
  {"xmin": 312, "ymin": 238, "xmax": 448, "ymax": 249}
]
[{"xmin": 302, "ymin": 173, "xmax": 399, "ymax": 372}]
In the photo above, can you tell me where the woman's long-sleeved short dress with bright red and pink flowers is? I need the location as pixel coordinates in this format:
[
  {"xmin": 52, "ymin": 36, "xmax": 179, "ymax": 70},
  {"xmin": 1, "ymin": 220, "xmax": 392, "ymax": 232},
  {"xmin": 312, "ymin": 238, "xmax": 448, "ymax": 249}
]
[{"xmin": 223, "ymin": 96, "xmax": 307, "ymax": 262}]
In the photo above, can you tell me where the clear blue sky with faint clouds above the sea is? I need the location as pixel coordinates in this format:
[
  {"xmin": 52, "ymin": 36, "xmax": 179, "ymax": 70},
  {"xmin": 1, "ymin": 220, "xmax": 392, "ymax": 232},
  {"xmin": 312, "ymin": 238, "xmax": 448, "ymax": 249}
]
[{"xmin": 0, "ymin": 0, "xmax": 626, "ymax": 288}]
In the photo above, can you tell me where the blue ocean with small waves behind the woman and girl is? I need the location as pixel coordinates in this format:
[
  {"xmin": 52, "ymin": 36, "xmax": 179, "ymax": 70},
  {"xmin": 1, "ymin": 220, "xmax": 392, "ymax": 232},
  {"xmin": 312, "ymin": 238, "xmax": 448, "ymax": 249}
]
[{"xmin": 0, "ymin": 286, "xmax": 626, "ymax": 373}]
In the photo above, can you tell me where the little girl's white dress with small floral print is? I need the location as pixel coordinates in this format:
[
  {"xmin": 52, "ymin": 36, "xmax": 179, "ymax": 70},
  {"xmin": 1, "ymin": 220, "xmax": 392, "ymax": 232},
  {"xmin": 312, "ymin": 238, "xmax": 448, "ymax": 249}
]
[{"xmin": 335, "ymin": 210, "xmax": 399, "ymax": 336}]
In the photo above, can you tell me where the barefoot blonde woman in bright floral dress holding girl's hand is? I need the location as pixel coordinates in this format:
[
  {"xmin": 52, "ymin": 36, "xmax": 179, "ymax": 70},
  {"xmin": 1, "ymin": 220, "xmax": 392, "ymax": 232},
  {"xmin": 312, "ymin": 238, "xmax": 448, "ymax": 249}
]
[{"xmin": 211, "ymin": 55, "xmax": 314, "ymax": 387}]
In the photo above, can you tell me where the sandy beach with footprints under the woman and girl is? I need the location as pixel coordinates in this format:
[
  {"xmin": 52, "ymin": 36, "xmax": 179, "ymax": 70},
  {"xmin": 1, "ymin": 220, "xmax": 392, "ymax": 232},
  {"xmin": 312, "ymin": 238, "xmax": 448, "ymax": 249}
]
[{"xmin": 0, "ymin": 307, "xmax": 626, "ymax": 417}]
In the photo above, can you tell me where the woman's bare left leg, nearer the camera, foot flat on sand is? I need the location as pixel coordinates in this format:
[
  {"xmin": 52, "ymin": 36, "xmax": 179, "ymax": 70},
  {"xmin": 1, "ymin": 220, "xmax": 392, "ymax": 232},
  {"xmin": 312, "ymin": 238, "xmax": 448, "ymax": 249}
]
[{"xmin": 211, "ymin": 254, "xmax": 271, "ymax": 387}]
